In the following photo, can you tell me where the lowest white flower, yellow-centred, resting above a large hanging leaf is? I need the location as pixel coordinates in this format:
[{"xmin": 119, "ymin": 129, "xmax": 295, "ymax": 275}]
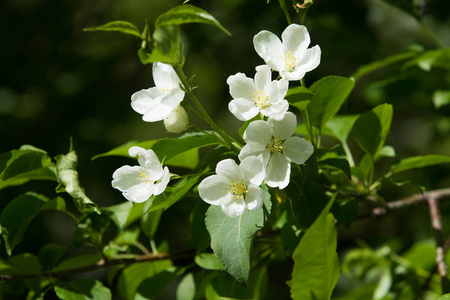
[{"xmin": 198, "ymin": 157, "xmax": 264, "ymax": 218}]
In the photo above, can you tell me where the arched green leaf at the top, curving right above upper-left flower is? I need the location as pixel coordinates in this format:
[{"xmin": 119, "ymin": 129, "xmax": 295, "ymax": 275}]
[{"xmin": 155, "ymin": 4, "xmax": 231, "ymax": 36}]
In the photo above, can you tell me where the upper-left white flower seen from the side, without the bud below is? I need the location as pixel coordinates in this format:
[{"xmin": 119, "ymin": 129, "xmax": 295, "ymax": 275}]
[{"xmin": 131, "ymin": 62, "xmax": 184, "ymax": 122}]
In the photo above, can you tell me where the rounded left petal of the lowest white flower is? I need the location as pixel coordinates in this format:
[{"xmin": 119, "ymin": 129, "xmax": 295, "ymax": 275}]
[{"xmin": 198, "ymin": 175, "xmax": 234, "ymax": 205}]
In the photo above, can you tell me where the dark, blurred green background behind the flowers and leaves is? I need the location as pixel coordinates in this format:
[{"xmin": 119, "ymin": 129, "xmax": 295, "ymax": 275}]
[{"xmin": 0, "ymin": 0, "xmax": 450, "ymax": 299}]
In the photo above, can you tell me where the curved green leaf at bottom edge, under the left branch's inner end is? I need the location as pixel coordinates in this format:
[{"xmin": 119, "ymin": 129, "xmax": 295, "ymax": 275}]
[{"xmin": 117, "ymin": 260, "xmax": 172, "ymax": 300}]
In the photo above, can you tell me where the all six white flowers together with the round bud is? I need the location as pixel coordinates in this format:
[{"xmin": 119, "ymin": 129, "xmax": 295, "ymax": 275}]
[{"xmin": 112, "ymin": 24, "xmax": 320, "ymax": 217}]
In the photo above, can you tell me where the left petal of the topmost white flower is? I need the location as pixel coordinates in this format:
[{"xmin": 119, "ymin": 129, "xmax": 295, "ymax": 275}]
[{"xmin": 253, "ymin": 30, "xmax": 284, "ymax": 71}]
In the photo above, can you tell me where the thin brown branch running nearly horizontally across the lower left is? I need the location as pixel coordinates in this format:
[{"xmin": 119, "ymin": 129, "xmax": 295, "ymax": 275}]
[{"xmin": 0, "ymin": 250, "xmax": 197, "ymax": 281}]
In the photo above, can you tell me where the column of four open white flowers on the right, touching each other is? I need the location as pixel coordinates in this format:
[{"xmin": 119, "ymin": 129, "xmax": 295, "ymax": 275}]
[{"xmin": 198, "ymin": 24, "xmax": 321, "ymax": 217}]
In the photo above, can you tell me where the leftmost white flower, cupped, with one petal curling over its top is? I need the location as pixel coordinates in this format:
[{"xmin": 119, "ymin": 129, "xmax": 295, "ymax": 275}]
[{"xmin": 111, "ymin": 146, "xmax": 170, "ymax": 203}]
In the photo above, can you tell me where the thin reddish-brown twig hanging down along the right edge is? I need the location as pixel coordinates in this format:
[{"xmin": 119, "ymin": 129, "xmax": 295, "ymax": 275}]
[{"xmin": 428, "ymin": 196, "xmax": 447, "ymax": 294}]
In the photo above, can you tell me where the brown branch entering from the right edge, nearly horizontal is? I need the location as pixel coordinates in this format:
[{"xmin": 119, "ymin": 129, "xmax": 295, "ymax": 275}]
[{"xmin": 355, "ymin": 188, "xmax": 450, "ymax": 220}]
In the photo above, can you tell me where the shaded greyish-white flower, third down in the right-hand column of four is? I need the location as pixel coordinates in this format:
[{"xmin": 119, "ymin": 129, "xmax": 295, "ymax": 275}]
[{"xmin": 239, "ymin": 112, "xmax": 314, "ymax": 189}]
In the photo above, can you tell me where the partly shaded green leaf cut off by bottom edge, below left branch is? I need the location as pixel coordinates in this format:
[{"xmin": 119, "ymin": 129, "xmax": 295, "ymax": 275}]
[{"xmin": 54, "ymin": 279, "xmax": 111, "ymax": 300}]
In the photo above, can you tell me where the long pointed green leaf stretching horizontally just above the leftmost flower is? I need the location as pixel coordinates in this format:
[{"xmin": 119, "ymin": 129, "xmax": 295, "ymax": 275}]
[{"xmin": 92, "ymin": 132, "xmax": 219, "ymax": 163}]
